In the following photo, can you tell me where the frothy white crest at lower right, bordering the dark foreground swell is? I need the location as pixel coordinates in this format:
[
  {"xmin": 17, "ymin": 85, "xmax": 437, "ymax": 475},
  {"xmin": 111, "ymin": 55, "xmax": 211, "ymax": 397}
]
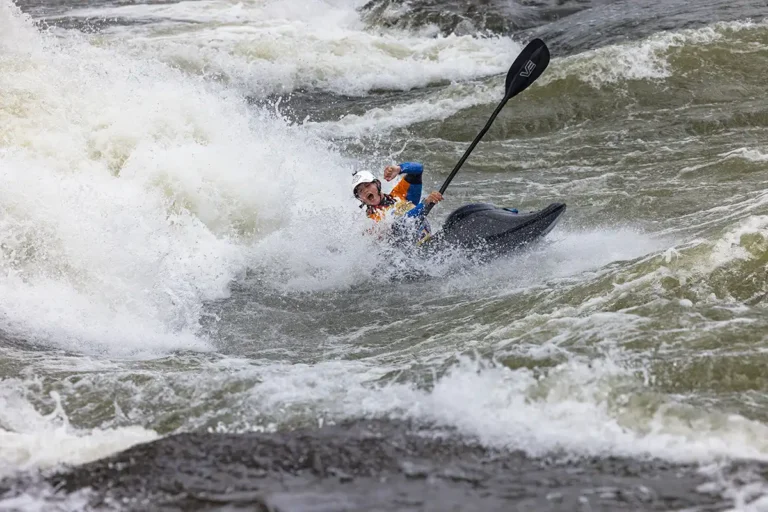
[{"xmin": 424, "ymin": 361, "xmax": 768, "ymax": 461}]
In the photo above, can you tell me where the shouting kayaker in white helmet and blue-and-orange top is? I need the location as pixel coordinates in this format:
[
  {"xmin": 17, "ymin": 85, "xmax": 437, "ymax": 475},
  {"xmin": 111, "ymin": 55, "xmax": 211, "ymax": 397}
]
[{"xmin": 352, "ymin": 162, "xmax": 443, "ymax": 241}]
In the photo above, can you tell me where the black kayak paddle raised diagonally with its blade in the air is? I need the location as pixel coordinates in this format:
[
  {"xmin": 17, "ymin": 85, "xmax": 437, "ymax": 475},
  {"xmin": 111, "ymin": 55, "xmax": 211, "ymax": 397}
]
[{"xmin": 424, "ymin": 38, "xmax": 549, "ymax": 217}]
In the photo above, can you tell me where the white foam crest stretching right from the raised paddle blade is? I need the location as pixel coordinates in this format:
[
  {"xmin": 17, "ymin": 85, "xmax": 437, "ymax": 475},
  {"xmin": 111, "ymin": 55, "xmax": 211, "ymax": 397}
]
[{"xmin": 542, "ymin": 21, "xmax": 766, "ymax": 88}]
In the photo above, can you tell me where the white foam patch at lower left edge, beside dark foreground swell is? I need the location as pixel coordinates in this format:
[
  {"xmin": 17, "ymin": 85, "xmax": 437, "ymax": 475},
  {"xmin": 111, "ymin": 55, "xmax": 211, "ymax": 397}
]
[{"xmin": 0, "ymin": 379, "xmax": 158, "ymax": 477}]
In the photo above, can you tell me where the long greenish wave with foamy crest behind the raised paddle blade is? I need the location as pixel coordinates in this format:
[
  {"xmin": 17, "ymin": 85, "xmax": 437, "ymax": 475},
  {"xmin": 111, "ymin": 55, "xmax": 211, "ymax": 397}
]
[{"xmin": 305, "ymin": 21, "xmax": 768, "ymax": 141}]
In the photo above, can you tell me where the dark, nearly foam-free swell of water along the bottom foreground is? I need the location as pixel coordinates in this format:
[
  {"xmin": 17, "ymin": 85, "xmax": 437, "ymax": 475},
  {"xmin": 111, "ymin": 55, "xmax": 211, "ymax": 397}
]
[{"xmin": 0, "ymin": 421, "xmax": 768, "ymax": 512}]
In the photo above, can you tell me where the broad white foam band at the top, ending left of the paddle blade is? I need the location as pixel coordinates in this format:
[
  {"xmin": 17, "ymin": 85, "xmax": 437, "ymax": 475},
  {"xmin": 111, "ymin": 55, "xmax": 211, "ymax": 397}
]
[{"xmin": 52, "ymin": 0, "xmax": 520, "ymax": 96}]
